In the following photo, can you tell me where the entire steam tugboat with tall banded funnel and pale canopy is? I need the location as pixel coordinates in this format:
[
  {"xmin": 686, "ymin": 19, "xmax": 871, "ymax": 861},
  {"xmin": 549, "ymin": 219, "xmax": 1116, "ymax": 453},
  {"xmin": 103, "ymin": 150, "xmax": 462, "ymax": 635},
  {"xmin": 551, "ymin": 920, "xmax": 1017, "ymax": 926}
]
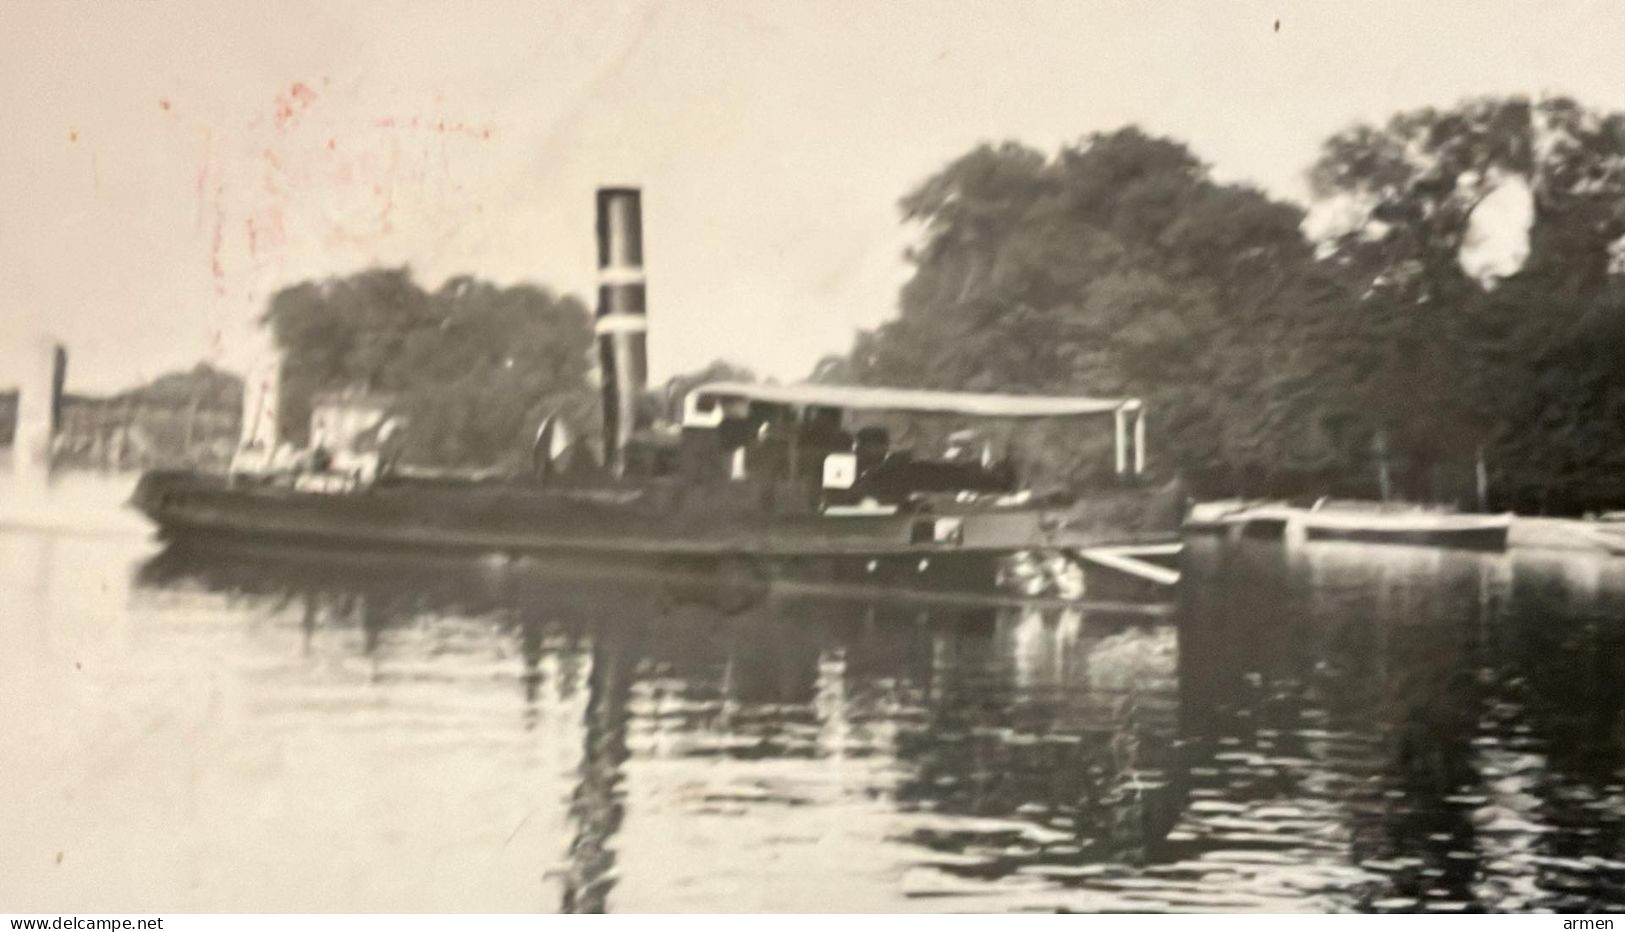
[{"xmin": 133, "ymin": 188, "xmax": 1183, "ymax": 591}]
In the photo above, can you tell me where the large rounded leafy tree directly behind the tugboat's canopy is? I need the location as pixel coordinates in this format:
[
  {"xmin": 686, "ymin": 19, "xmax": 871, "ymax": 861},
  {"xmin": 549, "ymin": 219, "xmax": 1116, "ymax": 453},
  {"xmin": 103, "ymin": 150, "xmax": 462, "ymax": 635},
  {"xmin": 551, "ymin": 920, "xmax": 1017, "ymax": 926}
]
[{"xmin": 821, "ymin": 127, "xmax": 1346, "ymax": 492}]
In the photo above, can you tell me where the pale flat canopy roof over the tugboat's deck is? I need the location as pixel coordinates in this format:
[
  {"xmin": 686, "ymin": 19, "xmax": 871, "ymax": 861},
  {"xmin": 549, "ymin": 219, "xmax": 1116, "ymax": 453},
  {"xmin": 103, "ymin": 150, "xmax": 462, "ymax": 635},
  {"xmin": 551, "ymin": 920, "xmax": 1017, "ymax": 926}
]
[{"xmin": 689, "ymin": 382, "xmax": 1141, "ymax": 417}]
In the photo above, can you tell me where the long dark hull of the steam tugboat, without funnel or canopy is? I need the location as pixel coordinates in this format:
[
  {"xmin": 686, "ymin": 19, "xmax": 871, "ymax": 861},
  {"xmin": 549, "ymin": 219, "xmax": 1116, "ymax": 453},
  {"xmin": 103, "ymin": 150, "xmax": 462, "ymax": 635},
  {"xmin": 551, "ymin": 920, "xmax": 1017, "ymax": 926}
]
[{"xmin": 133, "ymin": 472, "xmax": 1173, "ymax": 593}]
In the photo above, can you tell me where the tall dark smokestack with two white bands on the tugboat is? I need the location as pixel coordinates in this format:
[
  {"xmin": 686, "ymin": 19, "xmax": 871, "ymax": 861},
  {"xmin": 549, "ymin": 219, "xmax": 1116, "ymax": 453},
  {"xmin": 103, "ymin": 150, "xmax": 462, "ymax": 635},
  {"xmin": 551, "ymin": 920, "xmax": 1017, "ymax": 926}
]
[{"xmin": 593, "ymin": 188, "xmax": 648, "ymax": 476}]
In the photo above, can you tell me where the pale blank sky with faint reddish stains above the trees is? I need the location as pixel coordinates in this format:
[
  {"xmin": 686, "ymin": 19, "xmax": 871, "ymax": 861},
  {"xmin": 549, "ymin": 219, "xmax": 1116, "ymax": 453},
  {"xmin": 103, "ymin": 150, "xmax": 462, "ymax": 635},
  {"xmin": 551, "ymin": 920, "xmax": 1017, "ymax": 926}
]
[{"xmin": 0, "ymin": 0, "xmax": 1625, "ymax": 391}]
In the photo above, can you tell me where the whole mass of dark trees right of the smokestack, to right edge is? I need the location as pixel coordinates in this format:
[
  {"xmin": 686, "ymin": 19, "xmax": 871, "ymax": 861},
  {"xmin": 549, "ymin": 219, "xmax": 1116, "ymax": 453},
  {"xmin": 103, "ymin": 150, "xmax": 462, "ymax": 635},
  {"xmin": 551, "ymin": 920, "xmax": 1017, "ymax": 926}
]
[{"xmin": 814, "ymin": 97, "xmax": 1625, "ymax": 510}]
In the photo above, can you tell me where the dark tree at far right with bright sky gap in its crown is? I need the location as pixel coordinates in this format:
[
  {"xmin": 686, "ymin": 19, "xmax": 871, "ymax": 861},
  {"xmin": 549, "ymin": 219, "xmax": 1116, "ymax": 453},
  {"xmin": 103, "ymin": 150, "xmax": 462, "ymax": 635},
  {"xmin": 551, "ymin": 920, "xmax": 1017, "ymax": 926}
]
[{"xmin": 1310, "ymin": 97, "xmax": 1625, "ymax": 513}]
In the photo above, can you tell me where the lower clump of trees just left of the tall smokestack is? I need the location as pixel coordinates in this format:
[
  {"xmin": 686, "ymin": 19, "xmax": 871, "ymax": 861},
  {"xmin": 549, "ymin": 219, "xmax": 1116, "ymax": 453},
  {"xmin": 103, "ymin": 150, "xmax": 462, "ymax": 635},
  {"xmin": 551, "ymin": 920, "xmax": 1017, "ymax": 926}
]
[{"xmin": 265, "ymin": 270, "xmax": 598, "ymax": 468}]
